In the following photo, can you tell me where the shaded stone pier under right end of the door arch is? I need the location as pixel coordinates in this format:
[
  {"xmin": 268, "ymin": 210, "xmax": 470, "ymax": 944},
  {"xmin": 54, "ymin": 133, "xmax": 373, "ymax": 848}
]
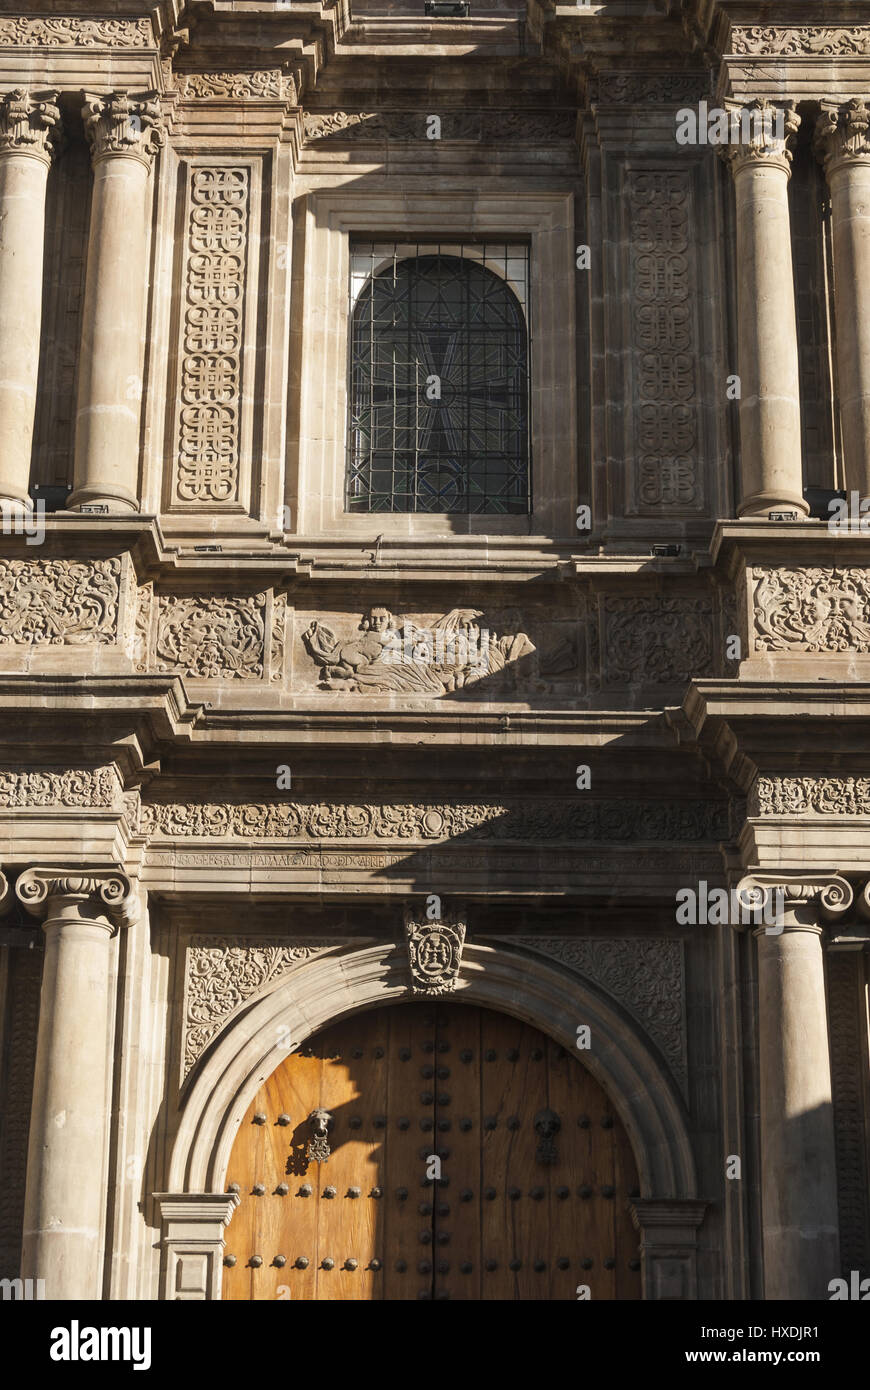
[{"xmin": 631, "ymin": 1198, "xmax": 709, "ymax": 1302}]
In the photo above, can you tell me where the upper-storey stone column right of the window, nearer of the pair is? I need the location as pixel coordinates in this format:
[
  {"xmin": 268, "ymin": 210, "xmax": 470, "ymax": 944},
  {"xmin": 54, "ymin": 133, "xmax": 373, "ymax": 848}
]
[{"xmin": 720, "ymin": 101, "xmax": 809, "ymax": 520}]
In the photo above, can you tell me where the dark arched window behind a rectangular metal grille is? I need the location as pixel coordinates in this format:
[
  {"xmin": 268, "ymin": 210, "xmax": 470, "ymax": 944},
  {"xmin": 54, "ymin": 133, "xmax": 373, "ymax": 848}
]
[{"xmin": 346, "ymin": 247, "xmax": 530, "ymax": 516}]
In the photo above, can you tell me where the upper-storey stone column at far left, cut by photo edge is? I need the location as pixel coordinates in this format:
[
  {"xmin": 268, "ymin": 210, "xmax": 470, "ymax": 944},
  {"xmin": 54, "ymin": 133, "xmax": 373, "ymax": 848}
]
[{"xmin": 0, "ymin": 90, "xmax": 60, "ymax": 516}]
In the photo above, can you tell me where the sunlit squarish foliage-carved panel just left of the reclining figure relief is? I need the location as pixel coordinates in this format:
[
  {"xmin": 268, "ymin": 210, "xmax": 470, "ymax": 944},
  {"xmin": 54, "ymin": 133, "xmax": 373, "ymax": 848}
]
[{"xmin": 154, "ymin": 594, "xmax": 267, "ymax": 681}]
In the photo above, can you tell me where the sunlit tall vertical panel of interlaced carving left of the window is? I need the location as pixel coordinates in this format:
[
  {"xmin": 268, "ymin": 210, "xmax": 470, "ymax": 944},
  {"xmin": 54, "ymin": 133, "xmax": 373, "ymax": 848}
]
[{"xmin": 172, "ymin": 164, "xmax": 250, "ymax": 506}]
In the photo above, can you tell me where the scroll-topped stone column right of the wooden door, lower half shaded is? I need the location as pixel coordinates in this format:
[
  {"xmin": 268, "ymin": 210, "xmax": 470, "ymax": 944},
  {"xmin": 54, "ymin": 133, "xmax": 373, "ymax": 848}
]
[{"xmin": 738, "ymin": 873, "xmax": 853, "ymax": 1300}]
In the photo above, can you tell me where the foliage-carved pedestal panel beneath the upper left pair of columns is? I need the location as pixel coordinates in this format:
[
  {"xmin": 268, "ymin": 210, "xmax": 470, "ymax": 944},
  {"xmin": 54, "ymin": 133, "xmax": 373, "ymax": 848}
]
[{"xmin": 0, "ymin": 557, "xmax": 121, "ymax": 646}]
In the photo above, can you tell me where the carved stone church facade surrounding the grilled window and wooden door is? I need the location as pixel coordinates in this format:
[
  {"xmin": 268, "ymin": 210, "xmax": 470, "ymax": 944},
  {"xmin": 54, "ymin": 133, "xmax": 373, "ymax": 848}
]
[{"xmin": 0, "ymin": 0, "xmax": 870, "ymax": 1300}]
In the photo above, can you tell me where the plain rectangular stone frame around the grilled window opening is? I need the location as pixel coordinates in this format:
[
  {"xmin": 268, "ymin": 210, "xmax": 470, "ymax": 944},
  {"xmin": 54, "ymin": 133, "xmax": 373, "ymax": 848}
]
[{"xmin": 285, "ymin": 189, "xmax": 578, "ymax": 539}]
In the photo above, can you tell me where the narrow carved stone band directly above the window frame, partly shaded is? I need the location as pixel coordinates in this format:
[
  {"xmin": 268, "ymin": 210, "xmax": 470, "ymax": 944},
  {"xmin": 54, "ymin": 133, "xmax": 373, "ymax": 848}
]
[{"xmin": 303, "ymin": 108, "xmax": 577, "ymax": 147}]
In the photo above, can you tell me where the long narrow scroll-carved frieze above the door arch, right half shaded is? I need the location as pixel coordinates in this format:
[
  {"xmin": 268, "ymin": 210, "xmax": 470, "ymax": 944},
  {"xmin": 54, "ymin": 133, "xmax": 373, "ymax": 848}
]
[{"xmin": 142, "ymin": 798, "xmax": 731, "ymax": 845}]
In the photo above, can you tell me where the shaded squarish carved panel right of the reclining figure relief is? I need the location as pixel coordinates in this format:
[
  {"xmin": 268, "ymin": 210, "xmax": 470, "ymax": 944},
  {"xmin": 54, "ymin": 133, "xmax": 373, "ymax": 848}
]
[{"xmin": 603, "ymin": 595, "xmax": 713, "ymax": 685}]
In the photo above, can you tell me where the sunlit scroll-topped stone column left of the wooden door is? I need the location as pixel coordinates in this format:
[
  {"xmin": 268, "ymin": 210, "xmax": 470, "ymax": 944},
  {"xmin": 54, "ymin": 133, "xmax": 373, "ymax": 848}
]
[{"xmin": 15, "ymin": 869, "xmax": 136, "ymax": 1300}]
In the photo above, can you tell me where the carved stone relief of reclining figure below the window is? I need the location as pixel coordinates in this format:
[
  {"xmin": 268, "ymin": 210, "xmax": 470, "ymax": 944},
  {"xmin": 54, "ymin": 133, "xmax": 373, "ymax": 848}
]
[{"xmin": 302, "ymin": 607, "xmax": 535, "ymax": 696}]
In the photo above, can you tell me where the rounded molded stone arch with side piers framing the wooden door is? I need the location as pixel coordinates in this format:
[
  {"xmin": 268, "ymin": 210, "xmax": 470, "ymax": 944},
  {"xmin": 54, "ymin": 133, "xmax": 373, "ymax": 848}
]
[{"xmin": 156, "ymin": 941, "xmax": 707, "ymax": 1298}]
